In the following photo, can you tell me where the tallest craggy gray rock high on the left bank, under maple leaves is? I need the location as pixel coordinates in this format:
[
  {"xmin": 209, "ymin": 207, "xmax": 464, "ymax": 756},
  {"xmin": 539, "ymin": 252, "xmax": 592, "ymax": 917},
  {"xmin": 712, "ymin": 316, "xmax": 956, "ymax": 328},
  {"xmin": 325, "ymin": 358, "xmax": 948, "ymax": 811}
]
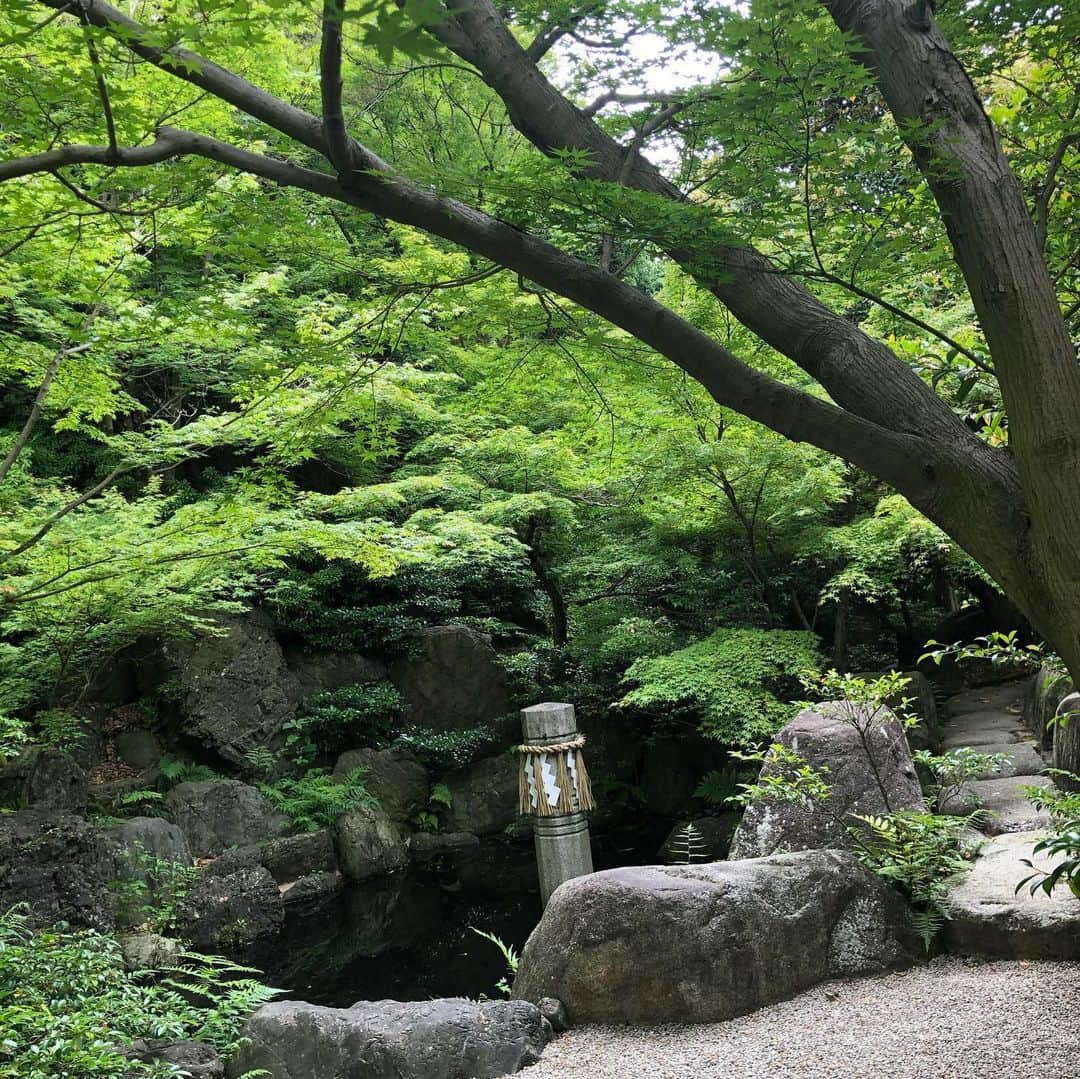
[{"xmin": 168, "ymin": 610, "xmax": 299, "ymax": 768}]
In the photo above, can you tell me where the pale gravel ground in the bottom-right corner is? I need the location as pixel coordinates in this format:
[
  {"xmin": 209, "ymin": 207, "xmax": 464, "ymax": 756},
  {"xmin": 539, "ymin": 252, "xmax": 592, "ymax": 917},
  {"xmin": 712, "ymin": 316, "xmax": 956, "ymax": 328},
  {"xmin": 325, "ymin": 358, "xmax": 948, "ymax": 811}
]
[{"xmin": 522, "ymin": 957, "xmax": 1080, "ymax": 1079}]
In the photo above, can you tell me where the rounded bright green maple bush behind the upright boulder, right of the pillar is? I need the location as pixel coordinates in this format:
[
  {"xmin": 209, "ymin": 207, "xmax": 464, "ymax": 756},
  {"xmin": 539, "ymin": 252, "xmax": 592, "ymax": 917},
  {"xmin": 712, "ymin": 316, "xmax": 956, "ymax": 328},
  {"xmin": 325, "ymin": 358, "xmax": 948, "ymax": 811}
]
[{"xmin": 619, "ymin": 630, "xmax": 818, "ymax": 745}]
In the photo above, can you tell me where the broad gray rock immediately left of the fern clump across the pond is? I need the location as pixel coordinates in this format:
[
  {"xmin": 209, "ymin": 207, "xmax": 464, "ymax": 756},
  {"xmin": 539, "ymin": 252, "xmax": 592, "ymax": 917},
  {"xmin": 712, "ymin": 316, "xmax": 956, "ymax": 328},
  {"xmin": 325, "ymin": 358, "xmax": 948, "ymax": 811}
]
[{"xmin": 165, "ymin": 780, "xmax": 288, "ymax": 857}]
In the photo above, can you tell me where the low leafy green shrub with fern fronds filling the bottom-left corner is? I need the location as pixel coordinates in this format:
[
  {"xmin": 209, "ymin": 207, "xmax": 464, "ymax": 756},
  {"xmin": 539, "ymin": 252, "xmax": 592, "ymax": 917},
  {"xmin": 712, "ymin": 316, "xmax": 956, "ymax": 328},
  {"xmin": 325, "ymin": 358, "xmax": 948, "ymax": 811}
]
[{"xmin": 0, "ymin": 908, "xmax": 276, "ymax": 1079}]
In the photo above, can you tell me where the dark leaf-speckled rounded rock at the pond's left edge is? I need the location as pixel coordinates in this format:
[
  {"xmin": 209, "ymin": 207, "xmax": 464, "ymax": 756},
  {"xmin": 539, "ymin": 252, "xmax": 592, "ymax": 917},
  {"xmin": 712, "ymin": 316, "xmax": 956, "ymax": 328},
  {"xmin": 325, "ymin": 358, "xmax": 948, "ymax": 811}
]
[{"xmin": 178, "ymin": 866, "xmax": 285, "ymax": 949}]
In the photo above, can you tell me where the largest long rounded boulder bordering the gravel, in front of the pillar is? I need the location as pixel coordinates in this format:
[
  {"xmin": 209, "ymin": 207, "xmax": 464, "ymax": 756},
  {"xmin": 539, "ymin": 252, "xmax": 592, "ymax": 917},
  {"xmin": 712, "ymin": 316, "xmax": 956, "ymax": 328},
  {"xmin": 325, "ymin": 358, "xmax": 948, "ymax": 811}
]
[{"xmin": 514, "ymin": 850, "xmax": 919, "ymax": 1024}]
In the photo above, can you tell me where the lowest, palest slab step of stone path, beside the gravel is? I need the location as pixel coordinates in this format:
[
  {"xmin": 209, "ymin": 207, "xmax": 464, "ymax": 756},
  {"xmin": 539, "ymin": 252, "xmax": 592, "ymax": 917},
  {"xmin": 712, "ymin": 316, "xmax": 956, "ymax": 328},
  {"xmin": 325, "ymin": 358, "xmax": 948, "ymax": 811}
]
[{"xmin": 943, "ymin": 832, "xmax": 1080, "ymax": 959}]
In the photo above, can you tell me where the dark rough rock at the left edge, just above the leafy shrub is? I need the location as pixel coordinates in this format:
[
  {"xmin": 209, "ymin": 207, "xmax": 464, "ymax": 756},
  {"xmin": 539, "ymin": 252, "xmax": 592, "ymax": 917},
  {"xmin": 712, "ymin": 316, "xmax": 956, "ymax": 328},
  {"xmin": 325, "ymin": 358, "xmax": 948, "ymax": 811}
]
[{"xmin": 0, "ymin": 809, "xmax": 113, "ymax": 930}]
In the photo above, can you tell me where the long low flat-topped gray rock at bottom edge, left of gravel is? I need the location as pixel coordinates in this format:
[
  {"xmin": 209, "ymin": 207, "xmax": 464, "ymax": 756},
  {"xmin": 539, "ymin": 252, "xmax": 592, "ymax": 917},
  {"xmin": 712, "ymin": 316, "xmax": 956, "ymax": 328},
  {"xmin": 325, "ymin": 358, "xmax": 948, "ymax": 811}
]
[{"xmin": 228, "ymin": 999, "xmax": 543, "ymax": 1079}]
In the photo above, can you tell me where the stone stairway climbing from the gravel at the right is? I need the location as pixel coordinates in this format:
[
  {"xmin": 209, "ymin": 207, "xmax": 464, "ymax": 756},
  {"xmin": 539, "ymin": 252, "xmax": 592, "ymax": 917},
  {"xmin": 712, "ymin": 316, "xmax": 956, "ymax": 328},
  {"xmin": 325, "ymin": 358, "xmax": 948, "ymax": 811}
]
[{"xmin": 942, "ymin": 680, "xmax": 1080, "ymax": 959}]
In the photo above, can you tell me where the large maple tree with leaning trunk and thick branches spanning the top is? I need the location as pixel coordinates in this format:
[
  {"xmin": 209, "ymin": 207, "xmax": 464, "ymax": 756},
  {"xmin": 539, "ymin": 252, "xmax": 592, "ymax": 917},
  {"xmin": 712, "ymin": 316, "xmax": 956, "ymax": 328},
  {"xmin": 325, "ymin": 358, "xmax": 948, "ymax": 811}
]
[{"xmin": 0, "ymin": 0, "xmax": 1080, "ymax": 676}]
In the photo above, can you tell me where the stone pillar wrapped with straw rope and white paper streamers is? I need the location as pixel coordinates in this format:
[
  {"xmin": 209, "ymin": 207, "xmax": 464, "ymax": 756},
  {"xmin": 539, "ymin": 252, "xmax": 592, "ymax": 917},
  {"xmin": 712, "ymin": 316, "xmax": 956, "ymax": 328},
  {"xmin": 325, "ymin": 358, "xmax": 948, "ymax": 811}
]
[{"xmin": 521, "ymin": 703, "xmax": 593, "ymax": 906}]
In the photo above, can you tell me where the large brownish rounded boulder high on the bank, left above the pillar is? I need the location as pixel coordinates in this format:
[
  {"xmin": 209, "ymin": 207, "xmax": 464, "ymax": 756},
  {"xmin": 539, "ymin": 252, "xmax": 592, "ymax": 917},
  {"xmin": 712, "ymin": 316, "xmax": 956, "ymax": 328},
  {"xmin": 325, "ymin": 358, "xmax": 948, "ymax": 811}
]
[{"xmin": 390, "ymin": 625, "xmax": 510, "ymax": 730}]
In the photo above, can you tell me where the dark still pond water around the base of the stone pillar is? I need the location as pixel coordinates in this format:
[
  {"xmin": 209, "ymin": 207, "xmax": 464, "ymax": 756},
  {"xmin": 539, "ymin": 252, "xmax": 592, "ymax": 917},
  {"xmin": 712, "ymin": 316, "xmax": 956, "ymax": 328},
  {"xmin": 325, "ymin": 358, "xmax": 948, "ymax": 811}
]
[{"xmin": 245, "ymin": 828, "xmax": 665, "ymax": 1007}]
